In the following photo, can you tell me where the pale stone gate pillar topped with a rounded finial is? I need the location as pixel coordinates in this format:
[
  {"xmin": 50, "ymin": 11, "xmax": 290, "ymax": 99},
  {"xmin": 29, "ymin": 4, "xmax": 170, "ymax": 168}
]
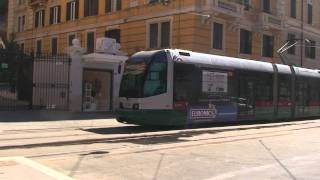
[{"xmin": 68, "ymin": 39, "xmax": 85, "ymax": 112}]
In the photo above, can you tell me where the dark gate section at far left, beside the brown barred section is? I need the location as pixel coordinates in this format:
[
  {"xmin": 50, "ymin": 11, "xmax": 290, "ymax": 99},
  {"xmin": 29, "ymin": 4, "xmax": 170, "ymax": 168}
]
[{"xmin": 0, "ymin": 49, "xmax": 32, "ymax": 111}]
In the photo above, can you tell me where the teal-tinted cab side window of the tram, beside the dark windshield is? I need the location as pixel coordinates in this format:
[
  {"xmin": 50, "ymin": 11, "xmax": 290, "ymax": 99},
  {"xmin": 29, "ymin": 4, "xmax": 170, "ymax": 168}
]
[{"xmin": 143, "ymin": 53, "xmax": 167, "ymax": 97}]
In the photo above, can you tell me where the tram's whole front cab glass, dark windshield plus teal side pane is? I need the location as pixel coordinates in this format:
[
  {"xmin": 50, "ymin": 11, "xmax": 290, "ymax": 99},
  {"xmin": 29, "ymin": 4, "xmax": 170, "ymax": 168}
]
[{"xmin": 119, "ymin": 51, "xmax": 167, "ymax": 98}]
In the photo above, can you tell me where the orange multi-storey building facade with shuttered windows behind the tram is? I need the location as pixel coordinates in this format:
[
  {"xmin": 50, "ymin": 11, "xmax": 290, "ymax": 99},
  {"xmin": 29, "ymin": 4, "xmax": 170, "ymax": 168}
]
[{"xmin": 8, "ymin": 0, "xmax": 320, "ymax": 68}]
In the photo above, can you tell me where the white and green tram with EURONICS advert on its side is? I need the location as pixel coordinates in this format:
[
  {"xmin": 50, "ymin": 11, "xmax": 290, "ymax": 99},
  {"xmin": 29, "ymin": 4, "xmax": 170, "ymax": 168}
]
[{"xmin": 117, "ymin": 49, "xmax": 320, "ymax": 126}]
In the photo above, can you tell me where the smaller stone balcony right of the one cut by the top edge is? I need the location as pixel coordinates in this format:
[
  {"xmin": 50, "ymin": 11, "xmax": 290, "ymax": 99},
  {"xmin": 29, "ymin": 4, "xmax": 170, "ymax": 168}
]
[{"xmin": 260, "ymin": 12, "xmax": 283, "ymax": 31}]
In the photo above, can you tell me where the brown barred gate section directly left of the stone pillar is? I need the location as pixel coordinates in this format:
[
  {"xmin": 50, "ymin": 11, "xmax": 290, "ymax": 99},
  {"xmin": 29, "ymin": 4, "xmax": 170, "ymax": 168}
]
[{"xmin": 32, "ymin": 55, "xmax": 71, "ymax": 110}]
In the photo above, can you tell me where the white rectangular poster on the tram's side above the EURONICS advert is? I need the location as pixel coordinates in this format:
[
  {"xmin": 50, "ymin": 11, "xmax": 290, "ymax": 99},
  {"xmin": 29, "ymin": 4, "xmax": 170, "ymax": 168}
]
[{"xmin": 202, "ymin": 71, "xmax": 228, "ymax": 93}]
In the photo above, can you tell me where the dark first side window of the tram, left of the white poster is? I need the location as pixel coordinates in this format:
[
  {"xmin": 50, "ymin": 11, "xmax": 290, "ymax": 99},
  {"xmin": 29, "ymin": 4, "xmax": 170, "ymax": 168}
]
[{"xmin": 174, "ymin": 63, "xmax": 201, "ymax": 104}]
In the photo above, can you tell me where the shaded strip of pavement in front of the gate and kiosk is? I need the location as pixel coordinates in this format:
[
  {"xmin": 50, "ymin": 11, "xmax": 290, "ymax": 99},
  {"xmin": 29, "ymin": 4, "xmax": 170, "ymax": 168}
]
[{"xmin": 0, "ymin": 111, "xmax": 115, "ymax": 122}]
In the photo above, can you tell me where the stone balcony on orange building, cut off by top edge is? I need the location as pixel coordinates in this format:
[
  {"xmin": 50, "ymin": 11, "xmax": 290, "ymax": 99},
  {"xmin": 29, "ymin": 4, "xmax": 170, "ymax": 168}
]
[{"xmin": 211, "ymin": 0, "xmax": 244, "ymax": 18}]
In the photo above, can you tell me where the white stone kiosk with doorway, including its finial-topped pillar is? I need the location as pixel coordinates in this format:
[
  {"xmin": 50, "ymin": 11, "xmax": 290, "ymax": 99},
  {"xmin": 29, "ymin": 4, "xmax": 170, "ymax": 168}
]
[{"xmin": 69, "ymin": 38, "xmax": 128, "ymax": 112}]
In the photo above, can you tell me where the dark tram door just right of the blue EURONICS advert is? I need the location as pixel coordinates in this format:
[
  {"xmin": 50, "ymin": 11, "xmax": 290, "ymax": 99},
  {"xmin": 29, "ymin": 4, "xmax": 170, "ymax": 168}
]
[{"xmin": 237, "ymin": 74, "xmax": 254, "ymax": 120}]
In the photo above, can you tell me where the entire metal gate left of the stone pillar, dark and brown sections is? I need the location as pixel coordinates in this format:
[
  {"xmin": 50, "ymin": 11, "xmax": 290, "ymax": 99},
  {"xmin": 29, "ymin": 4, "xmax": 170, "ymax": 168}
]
[{"xmin": 0, "ymin": 50, "xmax": 71, "ymax": 111}]
